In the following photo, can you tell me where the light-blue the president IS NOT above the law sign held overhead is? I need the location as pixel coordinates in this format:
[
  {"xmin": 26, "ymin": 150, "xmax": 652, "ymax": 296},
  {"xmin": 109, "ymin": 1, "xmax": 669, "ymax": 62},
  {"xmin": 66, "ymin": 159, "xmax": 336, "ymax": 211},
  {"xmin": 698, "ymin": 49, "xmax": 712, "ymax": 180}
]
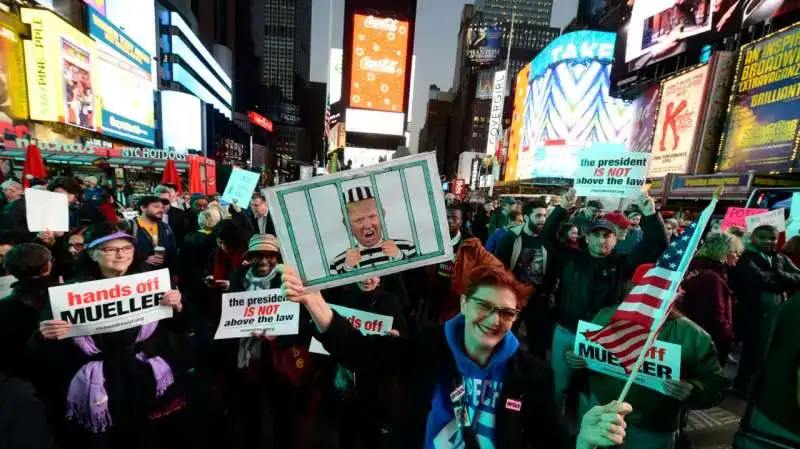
[{"xmin": 573, "ymin": 147, "xmax": 650, "ymax": 198}]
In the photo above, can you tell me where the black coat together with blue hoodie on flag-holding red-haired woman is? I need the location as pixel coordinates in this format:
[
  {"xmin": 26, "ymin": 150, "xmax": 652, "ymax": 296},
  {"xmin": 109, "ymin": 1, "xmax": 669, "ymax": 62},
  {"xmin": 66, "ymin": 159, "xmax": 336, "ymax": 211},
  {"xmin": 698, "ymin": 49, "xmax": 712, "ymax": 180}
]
[{"xmin": 317, "ymin": 313, "xmax": 576, "ymax": 449}]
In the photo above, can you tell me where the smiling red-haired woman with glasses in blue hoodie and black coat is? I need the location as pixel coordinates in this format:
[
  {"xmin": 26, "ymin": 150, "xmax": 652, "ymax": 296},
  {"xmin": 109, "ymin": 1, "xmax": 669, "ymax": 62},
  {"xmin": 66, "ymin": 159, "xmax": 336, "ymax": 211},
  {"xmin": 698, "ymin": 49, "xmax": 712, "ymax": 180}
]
[{"xmin": 278, "ymin": 265, "xmax": 630, "ymax": 449}]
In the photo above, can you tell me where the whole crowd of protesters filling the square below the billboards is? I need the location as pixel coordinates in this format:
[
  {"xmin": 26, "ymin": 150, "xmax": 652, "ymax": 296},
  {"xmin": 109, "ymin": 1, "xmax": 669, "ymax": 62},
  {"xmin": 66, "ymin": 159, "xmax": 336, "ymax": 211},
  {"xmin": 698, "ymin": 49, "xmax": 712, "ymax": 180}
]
[{"xmin": 0, "ymin": 172, "xmax": 800, "ymax": 449}]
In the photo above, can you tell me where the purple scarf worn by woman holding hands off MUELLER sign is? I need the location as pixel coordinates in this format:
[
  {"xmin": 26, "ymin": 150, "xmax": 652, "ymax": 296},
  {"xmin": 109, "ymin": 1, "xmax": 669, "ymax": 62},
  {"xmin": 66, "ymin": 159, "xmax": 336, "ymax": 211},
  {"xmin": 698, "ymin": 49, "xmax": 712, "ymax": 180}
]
[{"xmin": 67, "ymin": 323, "xmax": 174, "ymax": 433}]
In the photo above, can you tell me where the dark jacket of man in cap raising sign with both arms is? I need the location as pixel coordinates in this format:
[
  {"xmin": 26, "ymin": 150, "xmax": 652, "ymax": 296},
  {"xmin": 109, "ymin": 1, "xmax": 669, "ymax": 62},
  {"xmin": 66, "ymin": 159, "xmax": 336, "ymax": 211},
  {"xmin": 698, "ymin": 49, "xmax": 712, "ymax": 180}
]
[{"xmin": 541, "ymin": 206, "xmax": 669, "ymax": 332}]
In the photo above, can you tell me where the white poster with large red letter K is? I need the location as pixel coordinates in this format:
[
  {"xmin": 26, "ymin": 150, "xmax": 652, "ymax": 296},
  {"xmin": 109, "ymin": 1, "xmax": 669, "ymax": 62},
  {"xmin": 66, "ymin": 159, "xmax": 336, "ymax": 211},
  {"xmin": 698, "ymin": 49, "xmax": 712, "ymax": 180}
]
[{"xmin": 648, "ymin": 65, "xmax": 708, "ymax": 177}]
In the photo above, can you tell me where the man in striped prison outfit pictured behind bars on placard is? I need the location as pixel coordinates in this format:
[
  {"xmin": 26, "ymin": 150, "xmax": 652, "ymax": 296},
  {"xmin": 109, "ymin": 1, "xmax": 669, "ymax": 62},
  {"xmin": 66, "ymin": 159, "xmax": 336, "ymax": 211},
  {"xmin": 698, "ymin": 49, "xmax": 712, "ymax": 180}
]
[{"xmin": 330, "ymin": 186, "xmax": 416, "ymax": 274}]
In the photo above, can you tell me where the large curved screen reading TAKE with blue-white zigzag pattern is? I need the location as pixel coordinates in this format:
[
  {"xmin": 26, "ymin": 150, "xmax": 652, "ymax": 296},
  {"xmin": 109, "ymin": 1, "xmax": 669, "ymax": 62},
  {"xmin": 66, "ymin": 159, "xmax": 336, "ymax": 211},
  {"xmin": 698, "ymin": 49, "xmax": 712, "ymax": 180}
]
[{"xmin": 517, "ymin": 31, "xmax": 634, "ymax": 179}]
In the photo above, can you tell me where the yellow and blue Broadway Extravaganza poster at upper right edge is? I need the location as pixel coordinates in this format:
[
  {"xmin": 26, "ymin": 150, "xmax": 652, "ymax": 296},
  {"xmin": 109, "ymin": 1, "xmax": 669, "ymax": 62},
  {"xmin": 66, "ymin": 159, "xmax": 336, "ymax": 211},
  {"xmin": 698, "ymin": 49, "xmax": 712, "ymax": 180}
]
[{"xmin": 719, "ymin": 23, "xmax": 800, "ymax": 172}]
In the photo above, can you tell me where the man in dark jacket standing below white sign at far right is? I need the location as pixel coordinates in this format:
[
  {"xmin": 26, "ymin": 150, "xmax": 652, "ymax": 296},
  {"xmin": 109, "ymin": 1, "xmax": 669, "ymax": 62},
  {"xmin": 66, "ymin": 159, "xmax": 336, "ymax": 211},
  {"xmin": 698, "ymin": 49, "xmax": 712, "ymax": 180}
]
[{"xmin": 728, "ymin": 225, "xmax": 800, "ymax": 394}]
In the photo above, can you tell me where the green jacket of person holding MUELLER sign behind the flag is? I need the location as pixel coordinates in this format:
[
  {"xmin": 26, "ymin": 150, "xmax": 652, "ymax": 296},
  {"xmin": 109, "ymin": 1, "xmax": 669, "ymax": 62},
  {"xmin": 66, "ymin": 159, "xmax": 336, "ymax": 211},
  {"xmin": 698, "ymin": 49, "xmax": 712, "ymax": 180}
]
[{"xmin": 589, "ymin": 307, "xmax": 729, "ymax": 432}]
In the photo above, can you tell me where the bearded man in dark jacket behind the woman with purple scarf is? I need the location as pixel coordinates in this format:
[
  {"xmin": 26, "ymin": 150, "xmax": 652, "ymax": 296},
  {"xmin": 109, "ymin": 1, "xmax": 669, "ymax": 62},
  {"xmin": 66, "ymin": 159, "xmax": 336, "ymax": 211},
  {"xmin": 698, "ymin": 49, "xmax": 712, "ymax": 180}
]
[{"xmin": 131, "ymin": 195, "xmax": 178, "ymax": 275}]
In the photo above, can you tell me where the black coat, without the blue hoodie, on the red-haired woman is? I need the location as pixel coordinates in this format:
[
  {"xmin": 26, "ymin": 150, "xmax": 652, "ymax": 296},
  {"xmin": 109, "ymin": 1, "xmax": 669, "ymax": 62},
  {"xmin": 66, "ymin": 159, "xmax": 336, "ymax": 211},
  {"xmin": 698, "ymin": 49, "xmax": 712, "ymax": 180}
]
[{"xmin": 317, "ymin": 313, "xmax": 576, "ymax": 449}]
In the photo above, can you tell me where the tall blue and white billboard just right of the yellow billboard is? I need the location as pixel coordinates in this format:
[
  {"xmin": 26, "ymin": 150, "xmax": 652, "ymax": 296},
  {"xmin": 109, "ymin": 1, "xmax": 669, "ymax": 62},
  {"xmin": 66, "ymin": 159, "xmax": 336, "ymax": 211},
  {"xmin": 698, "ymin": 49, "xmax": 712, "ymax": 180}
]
[{"xmin": 89, "ymin": 8, "xmax": 156, "ymax": 145}]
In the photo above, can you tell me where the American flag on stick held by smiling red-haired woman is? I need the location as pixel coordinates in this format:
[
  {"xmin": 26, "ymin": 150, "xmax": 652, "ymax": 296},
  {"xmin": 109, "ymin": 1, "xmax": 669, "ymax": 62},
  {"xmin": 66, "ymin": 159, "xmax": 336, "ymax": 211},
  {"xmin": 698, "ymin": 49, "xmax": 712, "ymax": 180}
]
[{"xmin": 584, "ymin": 196, "xmax": 717, "ymax": 374}]
